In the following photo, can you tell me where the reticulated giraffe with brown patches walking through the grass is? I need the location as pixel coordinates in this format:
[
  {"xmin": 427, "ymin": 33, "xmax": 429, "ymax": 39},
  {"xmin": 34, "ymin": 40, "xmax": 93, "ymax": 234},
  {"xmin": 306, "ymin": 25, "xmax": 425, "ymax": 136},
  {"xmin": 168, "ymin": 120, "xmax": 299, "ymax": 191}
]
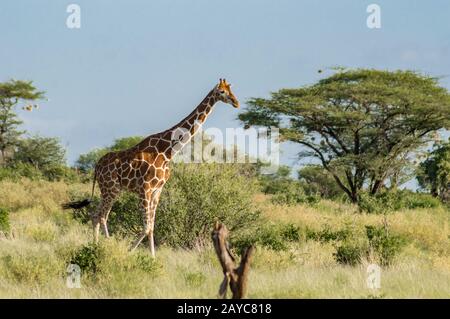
[{"xmin": 62, "ymin": 79, "xmax": 239, "ymax": 257}]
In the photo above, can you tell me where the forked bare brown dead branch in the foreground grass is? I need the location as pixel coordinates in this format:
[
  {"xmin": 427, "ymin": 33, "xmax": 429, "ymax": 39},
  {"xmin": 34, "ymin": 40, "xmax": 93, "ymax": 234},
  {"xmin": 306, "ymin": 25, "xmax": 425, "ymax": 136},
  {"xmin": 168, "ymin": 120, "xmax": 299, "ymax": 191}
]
[{"xmin": 211, "ymin": 222, "xmax": 255, "ymax": 299}]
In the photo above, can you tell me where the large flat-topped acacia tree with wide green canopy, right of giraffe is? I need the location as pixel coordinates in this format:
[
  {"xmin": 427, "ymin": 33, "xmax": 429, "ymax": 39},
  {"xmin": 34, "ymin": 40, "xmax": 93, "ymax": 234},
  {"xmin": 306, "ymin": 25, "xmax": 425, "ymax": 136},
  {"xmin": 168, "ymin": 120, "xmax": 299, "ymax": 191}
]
[{"xmin": 239, "ymin": 69, "xmax": 450, "ymax": 202}]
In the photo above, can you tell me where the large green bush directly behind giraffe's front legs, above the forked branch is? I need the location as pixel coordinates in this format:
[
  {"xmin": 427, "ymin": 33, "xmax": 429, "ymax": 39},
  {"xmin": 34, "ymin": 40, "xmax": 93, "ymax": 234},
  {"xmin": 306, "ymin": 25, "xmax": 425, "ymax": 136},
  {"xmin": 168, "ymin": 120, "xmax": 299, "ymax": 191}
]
[{"xmin": 155, "ymin": 164, "xmax": 260, "ymax": 248}]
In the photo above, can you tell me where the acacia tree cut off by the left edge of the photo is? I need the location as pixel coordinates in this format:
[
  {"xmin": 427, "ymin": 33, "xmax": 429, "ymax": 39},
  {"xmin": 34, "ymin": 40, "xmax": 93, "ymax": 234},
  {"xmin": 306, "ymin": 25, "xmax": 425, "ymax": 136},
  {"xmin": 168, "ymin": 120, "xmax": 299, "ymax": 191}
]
[{"xmin": 0, "ymin": 80, "xmax": 44, "ymax": 163}]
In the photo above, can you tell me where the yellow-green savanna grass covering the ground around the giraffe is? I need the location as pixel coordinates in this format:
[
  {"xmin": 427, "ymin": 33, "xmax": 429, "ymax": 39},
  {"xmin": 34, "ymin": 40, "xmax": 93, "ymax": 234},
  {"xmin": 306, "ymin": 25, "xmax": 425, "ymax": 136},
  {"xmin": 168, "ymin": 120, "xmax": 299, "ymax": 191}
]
[{"xmin": 0, "ymin": 179, "xmax": 450, "ymax": 298}]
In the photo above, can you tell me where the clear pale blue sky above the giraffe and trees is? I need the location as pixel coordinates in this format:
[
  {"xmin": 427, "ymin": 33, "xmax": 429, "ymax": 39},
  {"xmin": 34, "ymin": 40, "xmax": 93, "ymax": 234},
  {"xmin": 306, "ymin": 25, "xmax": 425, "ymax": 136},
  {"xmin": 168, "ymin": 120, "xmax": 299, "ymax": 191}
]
[{"xmin": 0, "ymin": 0, "xmax": 450, "ymax": 182}]
